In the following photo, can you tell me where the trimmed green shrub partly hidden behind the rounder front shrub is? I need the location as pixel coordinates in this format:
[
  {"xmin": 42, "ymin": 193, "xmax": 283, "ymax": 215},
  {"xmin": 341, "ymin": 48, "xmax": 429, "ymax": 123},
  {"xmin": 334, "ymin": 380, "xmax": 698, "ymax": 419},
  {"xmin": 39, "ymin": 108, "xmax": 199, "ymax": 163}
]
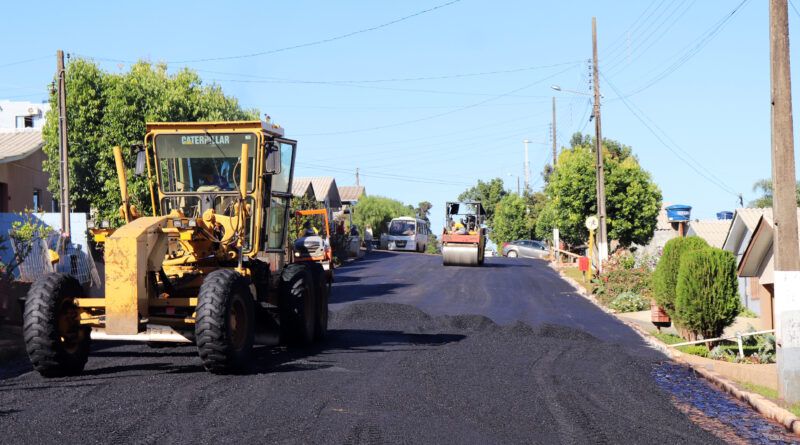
[{"xmin": 653, "ymin": 236, "xmax": 708, "ymax": 319}]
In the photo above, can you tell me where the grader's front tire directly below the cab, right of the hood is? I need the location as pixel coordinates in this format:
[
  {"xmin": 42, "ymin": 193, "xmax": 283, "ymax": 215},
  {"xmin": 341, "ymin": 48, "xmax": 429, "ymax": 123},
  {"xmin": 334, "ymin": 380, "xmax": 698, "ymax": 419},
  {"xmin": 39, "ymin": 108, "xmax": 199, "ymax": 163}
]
[{"xmin": 195, "ymin": 269, "xmax": 255, "ymax": 374}]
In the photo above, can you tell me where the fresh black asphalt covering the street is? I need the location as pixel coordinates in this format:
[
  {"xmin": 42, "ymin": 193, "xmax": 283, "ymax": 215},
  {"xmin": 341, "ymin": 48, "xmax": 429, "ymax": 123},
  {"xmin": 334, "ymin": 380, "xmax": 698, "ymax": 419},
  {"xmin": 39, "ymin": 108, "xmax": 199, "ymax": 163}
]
[{"xmin": 0, "ymin": 252, "xmax": 720, "ymax": 444}]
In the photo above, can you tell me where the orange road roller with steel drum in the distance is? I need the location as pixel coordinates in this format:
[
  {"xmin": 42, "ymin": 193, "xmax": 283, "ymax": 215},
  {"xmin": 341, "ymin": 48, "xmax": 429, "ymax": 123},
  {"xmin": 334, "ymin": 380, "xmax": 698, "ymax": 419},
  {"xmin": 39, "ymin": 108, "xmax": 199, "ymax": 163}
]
[{"xmin": 442, "ymin": 201, "xmax": 486, "ymax": 266}]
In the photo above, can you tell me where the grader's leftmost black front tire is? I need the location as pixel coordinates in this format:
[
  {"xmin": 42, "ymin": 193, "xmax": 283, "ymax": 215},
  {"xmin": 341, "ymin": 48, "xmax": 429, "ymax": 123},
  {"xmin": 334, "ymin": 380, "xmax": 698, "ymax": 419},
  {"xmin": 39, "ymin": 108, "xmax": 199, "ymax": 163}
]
[{"xmin": 23, "ymin": 273, "xmax": 91, "ymax": 377}]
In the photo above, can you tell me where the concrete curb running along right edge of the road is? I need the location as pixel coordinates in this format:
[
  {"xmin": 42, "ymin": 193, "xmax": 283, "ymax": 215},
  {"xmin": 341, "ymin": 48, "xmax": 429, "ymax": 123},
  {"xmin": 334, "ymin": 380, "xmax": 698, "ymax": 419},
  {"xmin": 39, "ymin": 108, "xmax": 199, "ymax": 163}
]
[{"xmin": 550, "ymin": 263, "xmax": 800, "ymax": 435}]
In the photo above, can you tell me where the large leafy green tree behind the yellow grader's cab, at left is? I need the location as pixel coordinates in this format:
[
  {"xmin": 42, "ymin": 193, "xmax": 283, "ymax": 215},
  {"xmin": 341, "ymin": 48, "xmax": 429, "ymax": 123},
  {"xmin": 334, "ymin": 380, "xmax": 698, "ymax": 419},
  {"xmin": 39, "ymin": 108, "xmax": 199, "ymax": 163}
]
[{"xmin": 42, "ymin": 57, "xmax": 259, "ymax": 224}]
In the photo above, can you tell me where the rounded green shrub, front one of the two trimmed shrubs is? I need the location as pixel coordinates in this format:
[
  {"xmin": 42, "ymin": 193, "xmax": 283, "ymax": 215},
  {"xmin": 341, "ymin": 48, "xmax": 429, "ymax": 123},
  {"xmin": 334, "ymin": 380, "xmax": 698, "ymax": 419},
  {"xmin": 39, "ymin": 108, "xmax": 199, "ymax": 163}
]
[{"xmin": 674, "ymin": 248, "xmax": 741, "ymax": 338}]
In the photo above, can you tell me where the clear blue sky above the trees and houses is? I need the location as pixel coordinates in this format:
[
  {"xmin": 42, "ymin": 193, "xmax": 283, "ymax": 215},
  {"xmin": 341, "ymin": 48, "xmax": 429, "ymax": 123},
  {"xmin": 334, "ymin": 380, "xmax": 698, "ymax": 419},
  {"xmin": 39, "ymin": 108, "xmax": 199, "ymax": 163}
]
[{"xmin": 0, "ymin": 0, "xmax": 800, "ymax": 236}]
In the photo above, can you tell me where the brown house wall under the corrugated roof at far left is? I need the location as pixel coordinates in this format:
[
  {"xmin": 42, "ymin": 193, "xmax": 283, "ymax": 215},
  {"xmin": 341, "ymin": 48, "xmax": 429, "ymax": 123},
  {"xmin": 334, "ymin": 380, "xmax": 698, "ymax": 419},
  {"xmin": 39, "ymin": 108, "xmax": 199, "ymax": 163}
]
[{"xmin": 0, "ymin": 150, "xmax": 53, "ymax": 212}]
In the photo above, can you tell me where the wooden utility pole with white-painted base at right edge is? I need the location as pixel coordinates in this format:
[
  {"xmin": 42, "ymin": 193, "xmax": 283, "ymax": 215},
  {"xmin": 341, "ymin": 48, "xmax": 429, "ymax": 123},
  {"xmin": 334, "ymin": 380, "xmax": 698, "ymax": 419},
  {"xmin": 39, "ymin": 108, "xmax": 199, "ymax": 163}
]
[{"xmin": 769, "ymin": 0, "xmax": 800, "ymax": 403}]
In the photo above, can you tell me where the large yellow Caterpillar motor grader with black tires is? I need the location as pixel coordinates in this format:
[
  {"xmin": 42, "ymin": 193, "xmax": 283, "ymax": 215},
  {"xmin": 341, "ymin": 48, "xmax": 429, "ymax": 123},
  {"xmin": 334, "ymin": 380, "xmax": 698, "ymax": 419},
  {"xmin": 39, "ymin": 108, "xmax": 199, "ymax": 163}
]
[{"xmin": 23, "ymin": 121, "xmax": 330, "ymax": 377}]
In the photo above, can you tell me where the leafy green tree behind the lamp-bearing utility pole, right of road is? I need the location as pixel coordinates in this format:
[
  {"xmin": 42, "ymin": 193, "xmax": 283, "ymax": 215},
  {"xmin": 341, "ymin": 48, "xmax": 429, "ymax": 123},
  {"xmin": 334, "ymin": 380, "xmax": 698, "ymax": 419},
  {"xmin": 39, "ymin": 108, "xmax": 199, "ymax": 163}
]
[{"xmin": 536, "ymin": 134, "xmax": 661, "ymax": 246}]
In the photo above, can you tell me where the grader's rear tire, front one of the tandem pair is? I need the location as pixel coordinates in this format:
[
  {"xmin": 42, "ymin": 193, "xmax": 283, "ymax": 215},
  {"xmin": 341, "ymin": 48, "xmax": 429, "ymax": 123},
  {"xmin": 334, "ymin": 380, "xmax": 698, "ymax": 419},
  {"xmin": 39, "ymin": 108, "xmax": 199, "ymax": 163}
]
[{"xmin": 279, "ymin": 263, "xmax": 319, "ymax": 346}]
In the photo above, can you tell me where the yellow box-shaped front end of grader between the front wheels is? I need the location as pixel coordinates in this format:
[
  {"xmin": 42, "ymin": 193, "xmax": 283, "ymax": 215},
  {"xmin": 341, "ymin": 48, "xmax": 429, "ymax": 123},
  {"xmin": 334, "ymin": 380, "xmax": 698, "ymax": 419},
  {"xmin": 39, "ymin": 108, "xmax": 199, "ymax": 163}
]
[{"xmin": 105, "ymin": 216, "xmax": 167, "ymax": 334}]
